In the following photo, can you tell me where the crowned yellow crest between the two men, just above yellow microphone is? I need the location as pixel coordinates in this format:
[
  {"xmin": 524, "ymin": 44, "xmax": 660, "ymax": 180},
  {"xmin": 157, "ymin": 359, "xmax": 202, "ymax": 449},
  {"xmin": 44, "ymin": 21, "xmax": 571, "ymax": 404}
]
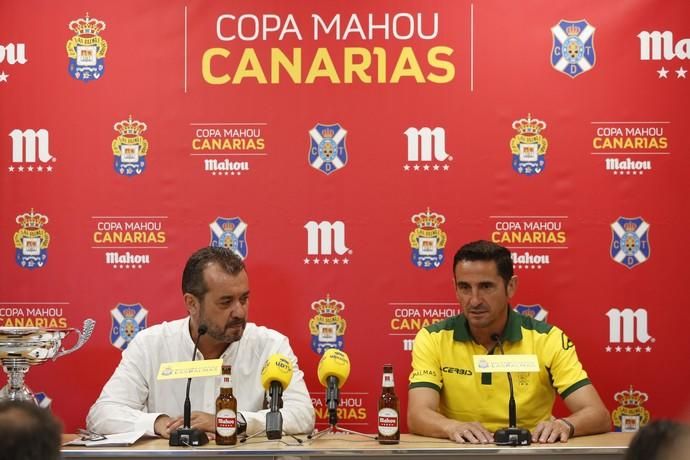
[{"xmin": 309, "ymin": 295, "xmax": 347, "ymax": 355}]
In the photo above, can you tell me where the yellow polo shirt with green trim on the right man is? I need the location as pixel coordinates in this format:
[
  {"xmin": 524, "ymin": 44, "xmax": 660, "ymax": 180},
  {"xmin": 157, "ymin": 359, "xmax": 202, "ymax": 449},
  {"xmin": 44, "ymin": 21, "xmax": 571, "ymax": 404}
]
[{"xmin": 410, "ymin": 308, "xmax": 590, "ymax": 432}]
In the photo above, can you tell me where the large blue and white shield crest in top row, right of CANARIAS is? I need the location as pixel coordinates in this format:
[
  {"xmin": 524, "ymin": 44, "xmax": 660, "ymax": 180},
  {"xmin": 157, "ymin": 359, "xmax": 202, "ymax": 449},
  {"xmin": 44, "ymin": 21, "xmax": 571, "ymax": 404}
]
[{"xmin": 551, "ymin": 19, "xmax": 596, "ymax": 78}]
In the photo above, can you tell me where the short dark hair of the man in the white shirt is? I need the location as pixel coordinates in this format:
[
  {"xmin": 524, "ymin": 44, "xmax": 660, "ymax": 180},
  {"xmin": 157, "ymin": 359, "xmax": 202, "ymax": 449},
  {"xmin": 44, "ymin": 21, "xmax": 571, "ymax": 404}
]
[{"xmin": 182, "ymin": 246, "xmax": 245, "ymax": 300}]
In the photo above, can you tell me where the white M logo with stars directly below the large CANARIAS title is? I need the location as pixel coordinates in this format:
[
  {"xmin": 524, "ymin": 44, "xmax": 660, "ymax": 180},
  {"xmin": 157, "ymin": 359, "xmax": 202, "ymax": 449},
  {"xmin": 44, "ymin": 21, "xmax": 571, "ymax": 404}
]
[{"xmin": 403, "ymin": 127, "xmax": 453, "ymax": 171}]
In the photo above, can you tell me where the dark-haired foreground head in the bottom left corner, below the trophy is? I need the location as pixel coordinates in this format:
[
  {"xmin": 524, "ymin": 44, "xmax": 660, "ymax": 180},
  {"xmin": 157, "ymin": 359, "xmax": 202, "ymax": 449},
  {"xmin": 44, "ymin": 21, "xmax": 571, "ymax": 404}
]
[{"xmin": 0, "ymin": 401, "xmax": 62, "ymax": 460}]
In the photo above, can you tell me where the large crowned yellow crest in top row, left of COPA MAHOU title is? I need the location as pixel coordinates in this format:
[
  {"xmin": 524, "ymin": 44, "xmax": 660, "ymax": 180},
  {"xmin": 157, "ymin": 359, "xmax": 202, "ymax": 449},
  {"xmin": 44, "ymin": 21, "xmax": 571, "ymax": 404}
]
[{"xmin": 67, "ymin": 13, "xmax": 108, "ymax": 82}]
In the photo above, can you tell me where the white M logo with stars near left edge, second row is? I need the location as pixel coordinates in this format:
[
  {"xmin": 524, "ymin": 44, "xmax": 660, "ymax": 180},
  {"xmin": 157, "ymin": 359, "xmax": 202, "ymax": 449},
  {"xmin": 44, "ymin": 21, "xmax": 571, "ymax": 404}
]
[{"xmin": 8, "ymin": 129, "xmax": 57, "ymax": 173}]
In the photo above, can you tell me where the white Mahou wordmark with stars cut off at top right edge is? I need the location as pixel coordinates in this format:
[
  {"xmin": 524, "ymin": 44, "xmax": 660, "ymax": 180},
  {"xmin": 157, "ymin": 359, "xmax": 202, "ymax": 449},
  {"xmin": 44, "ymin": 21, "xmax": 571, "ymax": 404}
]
[{"xmin": 637, "ymin": 30, "xmax": 690, "ymax": 79}]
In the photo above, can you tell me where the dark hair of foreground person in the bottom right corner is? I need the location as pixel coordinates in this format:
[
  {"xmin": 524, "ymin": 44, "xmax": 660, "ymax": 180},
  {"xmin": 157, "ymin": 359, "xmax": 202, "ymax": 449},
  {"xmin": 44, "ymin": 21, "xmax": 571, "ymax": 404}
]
[{"xmin": 624, "ymin": 419, "xmax": 690, "ymax": 460}]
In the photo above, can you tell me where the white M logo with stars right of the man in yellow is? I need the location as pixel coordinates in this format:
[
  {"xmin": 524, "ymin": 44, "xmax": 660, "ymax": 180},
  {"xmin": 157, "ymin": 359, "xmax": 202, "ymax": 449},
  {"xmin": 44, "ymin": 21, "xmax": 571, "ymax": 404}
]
[{"xmin": 606, "ymin": 308, "xmax": 656, "ymax": 353}]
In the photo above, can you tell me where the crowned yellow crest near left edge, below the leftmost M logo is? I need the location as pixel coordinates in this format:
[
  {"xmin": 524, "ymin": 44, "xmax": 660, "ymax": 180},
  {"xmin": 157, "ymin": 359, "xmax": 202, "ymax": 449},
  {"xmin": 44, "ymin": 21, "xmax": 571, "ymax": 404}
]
[{"xmin": 14, "ymin": 209, "xmax": 50, "ymax": 270}]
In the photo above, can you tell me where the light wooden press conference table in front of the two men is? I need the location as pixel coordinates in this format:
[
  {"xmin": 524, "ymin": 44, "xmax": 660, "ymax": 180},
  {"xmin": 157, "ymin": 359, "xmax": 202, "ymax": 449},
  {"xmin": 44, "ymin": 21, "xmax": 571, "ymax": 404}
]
[{"xmin": 62, "ymin": 433, "xmax": 633, "ymax": 460}]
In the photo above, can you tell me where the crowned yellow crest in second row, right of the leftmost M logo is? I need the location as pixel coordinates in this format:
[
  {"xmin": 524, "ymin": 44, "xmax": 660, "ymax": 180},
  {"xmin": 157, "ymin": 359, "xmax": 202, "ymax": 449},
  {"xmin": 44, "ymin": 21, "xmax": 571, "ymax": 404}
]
[{"xmin": 112, "ymin": 115, "xmax": 149, "ymax": 177}]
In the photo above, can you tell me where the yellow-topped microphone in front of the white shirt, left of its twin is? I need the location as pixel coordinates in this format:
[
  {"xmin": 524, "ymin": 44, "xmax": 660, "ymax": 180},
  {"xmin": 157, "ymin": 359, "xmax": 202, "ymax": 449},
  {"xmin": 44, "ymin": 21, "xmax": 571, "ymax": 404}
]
[{"xmin": 261, "ymin": 353, "xmax": 292, "ymax": 439}]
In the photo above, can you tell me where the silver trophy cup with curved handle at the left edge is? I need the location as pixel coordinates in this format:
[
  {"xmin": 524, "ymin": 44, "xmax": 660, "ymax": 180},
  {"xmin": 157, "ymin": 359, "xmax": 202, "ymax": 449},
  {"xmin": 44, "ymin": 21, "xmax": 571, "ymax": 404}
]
[{"xmin": 0, "ymin": 319, "xmax": 96, "ymax": 402}]
